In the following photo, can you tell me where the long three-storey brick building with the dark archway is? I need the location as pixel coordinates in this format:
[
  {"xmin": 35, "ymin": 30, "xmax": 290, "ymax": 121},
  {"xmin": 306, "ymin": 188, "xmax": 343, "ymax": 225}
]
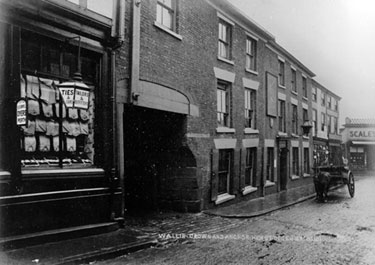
[{"xmin": 117, "ymin": 0, "xmax": 342, "ymax": 211}]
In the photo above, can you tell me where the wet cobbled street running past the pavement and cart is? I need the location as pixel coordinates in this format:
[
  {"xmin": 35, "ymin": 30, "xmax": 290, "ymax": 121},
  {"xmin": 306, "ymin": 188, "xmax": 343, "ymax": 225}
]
[{"xmin": 92, "ymin": 176, "xmax": 375, "ymax": 265}]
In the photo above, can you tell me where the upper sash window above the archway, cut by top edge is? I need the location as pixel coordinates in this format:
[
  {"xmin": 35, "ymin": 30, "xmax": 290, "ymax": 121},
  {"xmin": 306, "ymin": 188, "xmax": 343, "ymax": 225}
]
[{"xmin": 156, "ymin": 0, "xmax": 176, "ymax": 31}]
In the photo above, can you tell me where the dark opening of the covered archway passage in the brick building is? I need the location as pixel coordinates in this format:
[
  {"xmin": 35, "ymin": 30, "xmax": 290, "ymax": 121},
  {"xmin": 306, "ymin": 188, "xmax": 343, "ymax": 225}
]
[{"xmin": 124, "ymin": 106, "xmax": 186, "ymax": 214}]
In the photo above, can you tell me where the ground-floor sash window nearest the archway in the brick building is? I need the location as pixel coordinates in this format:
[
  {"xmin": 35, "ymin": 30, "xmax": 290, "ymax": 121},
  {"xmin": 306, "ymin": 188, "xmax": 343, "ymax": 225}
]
[{"xmin": 218, "ymin": 149, "xmax": 233, "ymax": 195}]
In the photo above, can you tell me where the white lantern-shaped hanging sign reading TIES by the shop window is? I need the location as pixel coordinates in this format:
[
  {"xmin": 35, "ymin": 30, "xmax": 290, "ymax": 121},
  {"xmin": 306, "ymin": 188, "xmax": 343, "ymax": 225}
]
[{"xmin": 58, "ymin": 78, "xmax": 90, "ymax": 110}]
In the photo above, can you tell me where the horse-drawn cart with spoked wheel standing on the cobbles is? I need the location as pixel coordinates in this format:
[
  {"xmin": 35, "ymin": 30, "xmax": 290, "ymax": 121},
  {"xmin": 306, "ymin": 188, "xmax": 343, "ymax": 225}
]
[{"xmin": 314, "ymin": 165, "xmax": 355, "ymax": 201}]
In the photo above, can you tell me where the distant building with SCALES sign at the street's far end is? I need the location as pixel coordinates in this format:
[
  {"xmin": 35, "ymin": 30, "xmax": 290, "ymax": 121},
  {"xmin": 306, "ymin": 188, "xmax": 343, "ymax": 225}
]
[{"xmin": 342, "ymin": 118, "xmax": 375, "ymax": 170}]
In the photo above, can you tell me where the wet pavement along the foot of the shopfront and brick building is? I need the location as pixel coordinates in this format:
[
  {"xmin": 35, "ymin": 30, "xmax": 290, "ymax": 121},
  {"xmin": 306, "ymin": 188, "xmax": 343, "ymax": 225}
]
[{"xmin": 0, "ymin": 177, "xmax": 362, "ymax": 265}]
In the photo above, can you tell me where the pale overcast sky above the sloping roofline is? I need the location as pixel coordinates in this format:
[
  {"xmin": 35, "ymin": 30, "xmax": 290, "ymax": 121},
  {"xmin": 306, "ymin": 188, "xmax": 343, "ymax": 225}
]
[{"xmin": 228, "ymin": 0, "xmax": 375, "ymax": 125}]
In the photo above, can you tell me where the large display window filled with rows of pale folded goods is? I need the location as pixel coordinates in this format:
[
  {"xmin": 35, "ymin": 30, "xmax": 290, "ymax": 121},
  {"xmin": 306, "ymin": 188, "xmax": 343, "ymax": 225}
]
[{"xmin": 20, "ymin": 32, "xmax": 99, "ymax": 168}]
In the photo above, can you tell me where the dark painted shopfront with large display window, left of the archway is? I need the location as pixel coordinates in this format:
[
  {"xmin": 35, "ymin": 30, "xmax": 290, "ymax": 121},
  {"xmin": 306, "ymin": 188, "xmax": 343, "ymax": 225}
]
[{"xmin": 0, "ymin": 1, "xmax": 125, "ymax": 236}]
